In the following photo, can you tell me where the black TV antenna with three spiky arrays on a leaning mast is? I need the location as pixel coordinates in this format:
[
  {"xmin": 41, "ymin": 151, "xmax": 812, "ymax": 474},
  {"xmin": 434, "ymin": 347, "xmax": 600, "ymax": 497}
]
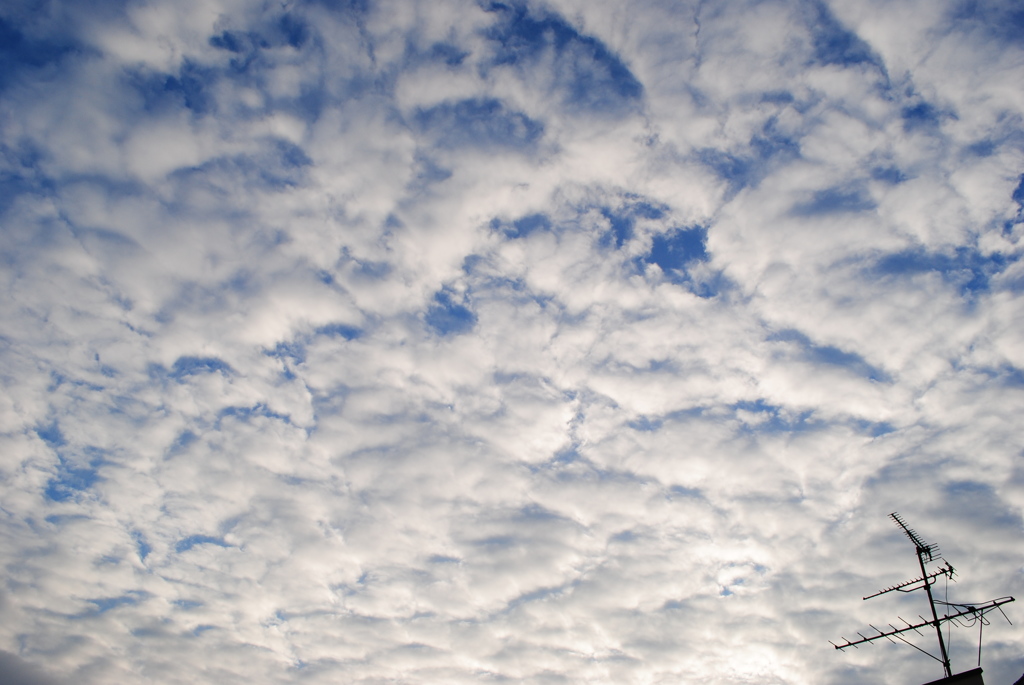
[{"xmin": 829, "ymin": 512, "xmax": 1014, "ymax": 678}]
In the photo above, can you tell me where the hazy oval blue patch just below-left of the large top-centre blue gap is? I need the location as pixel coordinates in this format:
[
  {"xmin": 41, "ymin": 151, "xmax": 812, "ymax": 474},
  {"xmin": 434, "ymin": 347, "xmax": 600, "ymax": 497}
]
[{"xmin": 413, "ymin": 98, "xmax": 544, "ymax": 148}]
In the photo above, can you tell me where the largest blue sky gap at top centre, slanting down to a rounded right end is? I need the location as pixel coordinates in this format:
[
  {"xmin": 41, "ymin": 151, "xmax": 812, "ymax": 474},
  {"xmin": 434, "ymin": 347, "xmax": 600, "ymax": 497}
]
[{"xmin": 484, "ymin": 2, "xmax": 643, "ymax": 115}]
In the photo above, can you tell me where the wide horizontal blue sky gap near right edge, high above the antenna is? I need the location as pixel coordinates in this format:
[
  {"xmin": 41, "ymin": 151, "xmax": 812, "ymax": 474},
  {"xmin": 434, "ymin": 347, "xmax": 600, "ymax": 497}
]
[{"xmin": 870, "ymin": 247, "xmax": 1018, "ymax": 295}]
